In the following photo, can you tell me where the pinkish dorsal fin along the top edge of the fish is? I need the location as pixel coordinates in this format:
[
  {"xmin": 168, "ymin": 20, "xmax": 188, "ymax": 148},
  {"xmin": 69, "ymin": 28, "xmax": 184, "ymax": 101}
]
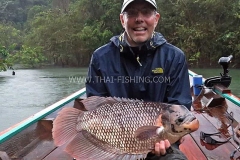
[{"xmin": 78, "ymin": 96, "xmax": 142, "ymax": 111}]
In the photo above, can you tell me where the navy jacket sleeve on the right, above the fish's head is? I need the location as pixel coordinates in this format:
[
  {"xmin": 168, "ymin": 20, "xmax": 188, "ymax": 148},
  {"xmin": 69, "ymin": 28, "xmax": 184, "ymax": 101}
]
[{"xmin": 166, "ymin": 52, "xmax": 192, "ymax": 110}]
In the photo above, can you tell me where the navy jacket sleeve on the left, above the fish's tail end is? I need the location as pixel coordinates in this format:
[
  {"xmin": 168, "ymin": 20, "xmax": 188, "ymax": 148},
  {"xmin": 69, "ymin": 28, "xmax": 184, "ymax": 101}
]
[{"xmin": 85, "ymin": 53, "xmax": 108, "ymax": 97}]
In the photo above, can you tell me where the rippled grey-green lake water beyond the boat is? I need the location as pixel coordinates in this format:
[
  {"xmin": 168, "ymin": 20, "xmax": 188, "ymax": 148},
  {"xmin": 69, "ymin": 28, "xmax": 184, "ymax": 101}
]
[{"xmin": 0, "ymin": 68, "xmax": 240, "ymax": 132}]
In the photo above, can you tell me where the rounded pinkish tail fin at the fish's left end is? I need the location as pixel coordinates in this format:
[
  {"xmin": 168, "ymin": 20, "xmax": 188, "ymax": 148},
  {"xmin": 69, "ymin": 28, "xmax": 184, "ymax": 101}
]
[{"xmin": 52, "ymin": 108, "xmax": 83, "ymax": 146}]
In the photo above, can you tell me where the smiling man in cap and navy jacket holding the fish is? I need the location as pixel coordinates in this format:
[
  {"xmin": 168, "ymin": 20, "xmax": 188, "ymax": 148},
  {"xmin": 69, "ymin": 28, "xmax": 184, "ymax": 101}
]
[{"xmin": 86, "ymin": 0, "xmax": 192, "ymax": 159}]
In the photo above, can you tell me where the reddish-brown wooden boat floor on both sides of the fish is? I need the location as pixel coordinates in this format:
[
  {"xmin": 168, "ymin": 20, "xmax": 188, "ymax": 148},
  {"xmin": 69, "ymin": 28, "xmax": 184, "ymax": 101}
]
[{"xmin": 0, "ymin": 89, "xmax": 240, "ymax": 160}]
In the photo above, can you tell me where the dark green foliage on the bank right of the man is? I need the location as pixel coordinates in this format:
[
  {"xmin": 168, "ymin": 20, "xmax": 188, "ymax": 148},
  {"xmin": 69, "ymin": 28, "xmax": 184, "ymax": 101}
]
[{"xmin": 158, "ymin": 0, "xmax": 240, "ymax": 67}]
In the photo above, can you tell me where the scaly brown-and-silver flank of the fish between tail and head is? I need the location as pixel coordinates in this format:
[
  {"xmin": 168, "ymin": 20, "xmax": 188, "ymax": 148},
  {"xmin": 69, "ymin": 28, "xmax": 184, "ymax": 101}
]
[{"xmin": 82, "ymin": 102, "xmax": 161, "ymax": 153}]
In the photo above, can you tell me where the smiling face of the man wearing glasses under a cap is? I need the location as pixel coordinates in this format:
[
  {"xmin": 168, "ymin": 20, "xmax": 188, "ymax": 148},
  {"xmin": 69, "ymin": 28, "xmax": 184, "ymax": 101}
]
[{"xmin": 120, "ymin": 1, "xmax": 160, "ymax": 47}]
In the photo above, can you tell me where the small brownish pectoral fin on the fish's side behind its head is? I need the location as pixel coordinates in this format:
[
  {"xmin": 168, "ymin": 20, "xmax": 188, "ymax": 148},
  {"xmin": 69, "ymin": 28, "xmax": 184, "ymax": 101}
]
[{"xmin": 135, "ymin": 126, "xmax": 159, "ymax": 141}]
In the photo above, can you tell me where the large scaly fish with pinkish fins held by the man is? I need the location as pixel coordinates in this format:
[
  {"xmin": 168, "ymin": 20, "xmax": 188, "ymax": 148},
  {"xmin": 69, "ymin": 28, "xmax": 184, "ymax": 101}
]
[{"xmin": 53, "ymin": 96, "xmax": 199, "ymax": 160}]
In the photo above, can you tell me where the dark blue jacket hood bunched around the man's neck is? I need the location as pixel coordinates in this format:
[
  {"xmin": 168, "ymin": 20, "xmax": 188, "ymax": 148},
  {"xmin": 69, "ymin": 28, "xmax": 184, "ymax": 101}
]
[{"xmin": 110, "ymin": 32, "xmax": 167, "ymax": 52}]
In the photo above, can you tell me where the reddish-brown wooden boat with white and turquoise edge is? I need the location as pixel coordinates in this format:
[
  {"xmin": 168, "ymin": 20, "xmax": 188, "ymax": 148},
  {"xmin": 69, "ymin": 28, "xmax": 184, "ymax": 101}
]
[{"xmin": 0, "ymin": 57, "xmax": 240, "ymax": 160}]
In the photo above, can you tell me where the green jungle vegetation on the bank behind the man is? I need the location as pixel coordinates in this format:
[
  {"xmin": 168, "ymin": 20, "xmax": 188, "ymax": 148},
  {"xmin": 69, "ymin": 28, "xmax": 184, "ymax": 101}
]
[{"xmin": 0, "ymin": 0, "xmax": 240, "ymax": 71}]
